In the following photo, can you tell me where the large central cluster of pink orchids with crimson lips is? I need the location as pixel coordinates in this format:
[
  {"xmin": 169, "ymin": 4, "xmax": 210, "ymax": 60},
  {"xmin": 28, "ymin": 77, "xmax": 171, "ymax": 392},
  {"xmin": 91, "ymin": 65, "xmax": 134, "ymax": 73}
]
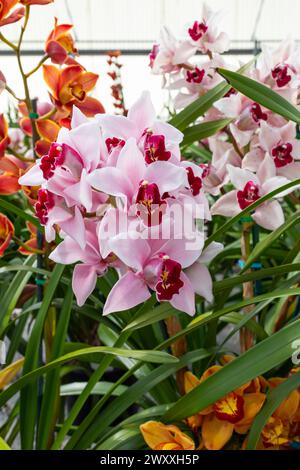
[{"xmin": 20, "ymin": 92, "xmax": 222, "ymax": 315}]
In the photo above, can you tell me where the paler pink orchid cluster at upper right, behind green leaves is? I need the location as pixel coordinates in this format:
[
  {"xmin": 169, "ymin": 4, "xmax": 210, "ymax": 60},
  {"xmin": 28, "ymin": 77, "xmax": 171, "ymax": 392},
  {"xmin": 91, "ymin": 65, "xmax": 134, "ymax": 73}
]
[{"xmin": 150, "ymin": 3, "xmax": 300, "ymax": 230}]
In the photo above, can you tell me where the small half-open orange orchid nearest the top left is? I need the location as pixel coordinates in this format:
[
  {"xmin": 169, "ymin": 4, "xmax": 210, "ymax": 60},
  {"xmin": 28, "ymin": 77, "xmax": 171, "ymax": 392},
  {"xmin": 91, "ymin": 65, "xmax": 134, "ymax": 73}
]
[{"xmin": 45, "ymin": 18, "xmax": 77, "ymax": 65}]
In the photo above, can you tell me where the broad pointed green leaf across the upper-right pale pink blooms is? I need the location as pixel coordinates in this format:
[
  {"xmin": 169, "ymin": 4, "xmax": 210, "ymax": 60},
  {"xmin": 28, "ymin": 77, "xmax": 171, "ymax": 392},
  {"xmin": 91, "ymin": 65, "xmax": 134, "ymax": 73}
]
[{"xmin": 218, "ymin": 68, "xmax": 300, "ymax": 124}]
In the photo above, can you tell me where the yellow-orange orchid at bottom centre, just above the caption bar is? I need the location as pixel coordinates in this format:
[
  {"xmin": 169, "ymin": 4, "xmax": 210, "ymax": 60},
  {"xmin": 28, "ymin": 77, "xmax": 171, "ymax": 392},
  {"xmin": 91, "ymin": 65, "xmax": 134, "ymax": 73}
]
[{"xmin": 140, "ymin": 421, "xmax": 195, "ymax": 450}]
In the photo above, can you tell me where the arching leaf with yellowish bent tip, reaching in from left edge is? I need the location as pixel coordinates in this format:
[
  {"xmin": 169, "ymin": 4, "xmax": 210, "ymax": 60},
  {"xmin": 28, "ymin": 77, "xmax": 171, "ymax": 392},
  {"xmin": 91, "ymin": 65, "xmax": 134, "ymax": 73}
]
[{"xmin": 0, "ymin": 346, "xmax": 179, "ymax": 407}]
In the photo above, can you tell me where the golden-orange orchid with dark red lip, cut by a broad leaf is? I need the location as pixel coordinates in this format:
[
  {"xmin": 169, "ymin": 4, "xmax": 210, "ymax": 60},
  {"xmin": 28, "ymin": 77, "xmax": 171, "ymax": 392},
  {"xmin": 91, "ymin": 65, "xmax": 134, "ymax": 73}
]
[{"xmin": 184, "ymin": 366, "xmax": 266, "ymax": 450}]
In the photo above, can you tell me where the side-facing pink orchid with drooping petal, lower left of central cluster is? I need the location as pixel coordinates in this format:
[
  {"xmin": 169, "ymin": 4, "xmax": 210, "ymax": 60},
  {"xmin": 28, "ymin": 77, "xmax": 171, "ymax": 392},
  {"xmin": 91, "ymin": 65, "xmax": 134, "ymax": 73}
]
[{"xmin": 49, "ymin": 219, "xmax": 108, "ymax": 307}]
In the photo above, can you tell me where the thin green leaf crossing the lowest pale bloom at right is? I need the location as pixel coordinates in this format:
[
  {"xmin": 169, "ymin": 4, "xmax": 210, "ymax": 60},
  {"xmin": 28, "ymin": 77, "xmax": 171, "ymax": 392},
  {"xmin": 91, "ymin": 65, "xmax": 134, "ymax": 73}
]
[{"xmin": 205, "ymin": 179, "xmax": 300, "ymax": 247}]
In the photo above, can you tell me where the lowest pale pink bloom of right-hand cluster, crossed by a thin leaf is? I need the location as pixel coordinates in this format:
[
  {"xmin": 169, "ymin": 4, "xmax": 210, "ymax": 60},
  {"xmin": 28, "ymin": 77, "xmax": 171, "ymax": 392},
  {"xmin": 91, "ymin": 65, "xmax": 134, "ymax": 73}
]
[{"xmin": 211, "ymin": 155, "xmax": 289, "ymax": 230}]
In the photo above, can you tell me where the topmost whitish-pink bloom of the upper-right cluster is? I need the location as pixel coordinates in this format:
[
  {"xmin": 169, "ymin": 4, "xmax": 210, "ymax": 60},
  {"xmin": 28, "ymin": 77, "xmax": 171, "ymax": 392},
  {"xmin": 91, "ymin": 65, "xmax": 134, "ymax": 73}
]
[{"xmin": 188, "ymin": 5, "xmax": 229, "ymax": 54}]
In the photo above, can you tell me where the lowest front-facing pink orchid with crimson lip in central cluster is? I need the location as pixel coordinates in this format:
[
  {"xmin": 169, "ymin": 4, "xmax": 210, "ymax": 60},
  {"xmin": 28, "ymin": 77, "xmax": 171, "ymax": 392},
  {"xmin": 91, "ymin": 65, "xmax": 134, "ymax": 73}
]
[{"xmin": 103, "ymin": 226, "xmax": 205, "ymax": 315}]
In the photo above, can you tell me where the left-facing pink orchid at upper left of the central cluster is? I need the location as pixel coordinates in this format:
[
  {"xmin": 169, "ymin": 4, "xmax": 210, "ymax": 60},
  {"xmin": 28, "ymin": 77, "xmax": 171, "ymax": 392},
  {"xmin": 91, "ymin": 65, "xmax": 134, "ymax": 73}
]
[{"xmin": 19, "ymin": 108, "xmax": 107, "ymax": 212}]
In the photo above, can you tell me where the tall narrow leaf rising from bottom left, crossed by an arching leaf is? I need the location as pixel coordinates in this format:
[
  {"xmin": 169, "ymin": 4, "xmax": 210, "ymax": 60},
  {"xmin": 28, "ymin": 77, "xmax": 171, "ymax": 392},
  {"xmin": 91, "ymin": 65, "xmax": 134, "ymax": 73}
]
[{"xmin": 19, "ymin": 264, "xmax": 65, "ymax": 450}]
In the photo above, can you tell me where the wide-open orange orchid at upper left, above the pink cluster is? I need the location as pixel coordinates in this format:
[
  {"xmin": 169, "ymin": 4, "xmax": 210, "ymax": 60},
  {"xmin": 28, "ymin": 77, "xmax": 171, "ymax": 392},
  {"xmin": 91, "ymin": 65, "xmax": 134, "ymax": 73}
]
[{"xmin": 43, "ymin": 64, "xmax": 104, "ymax": 119}]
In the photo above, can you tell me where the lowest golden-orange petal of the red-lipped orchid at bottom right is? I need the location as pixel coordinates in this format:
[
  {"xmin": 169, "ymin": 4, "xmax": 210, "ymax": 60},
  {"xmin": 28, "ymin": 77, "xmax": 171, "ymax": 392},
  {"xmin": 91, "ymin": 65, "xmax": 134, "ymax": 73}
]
[{"xmin": 202, "ymin": 413, "xmax": 234, "ymax": 450}]
